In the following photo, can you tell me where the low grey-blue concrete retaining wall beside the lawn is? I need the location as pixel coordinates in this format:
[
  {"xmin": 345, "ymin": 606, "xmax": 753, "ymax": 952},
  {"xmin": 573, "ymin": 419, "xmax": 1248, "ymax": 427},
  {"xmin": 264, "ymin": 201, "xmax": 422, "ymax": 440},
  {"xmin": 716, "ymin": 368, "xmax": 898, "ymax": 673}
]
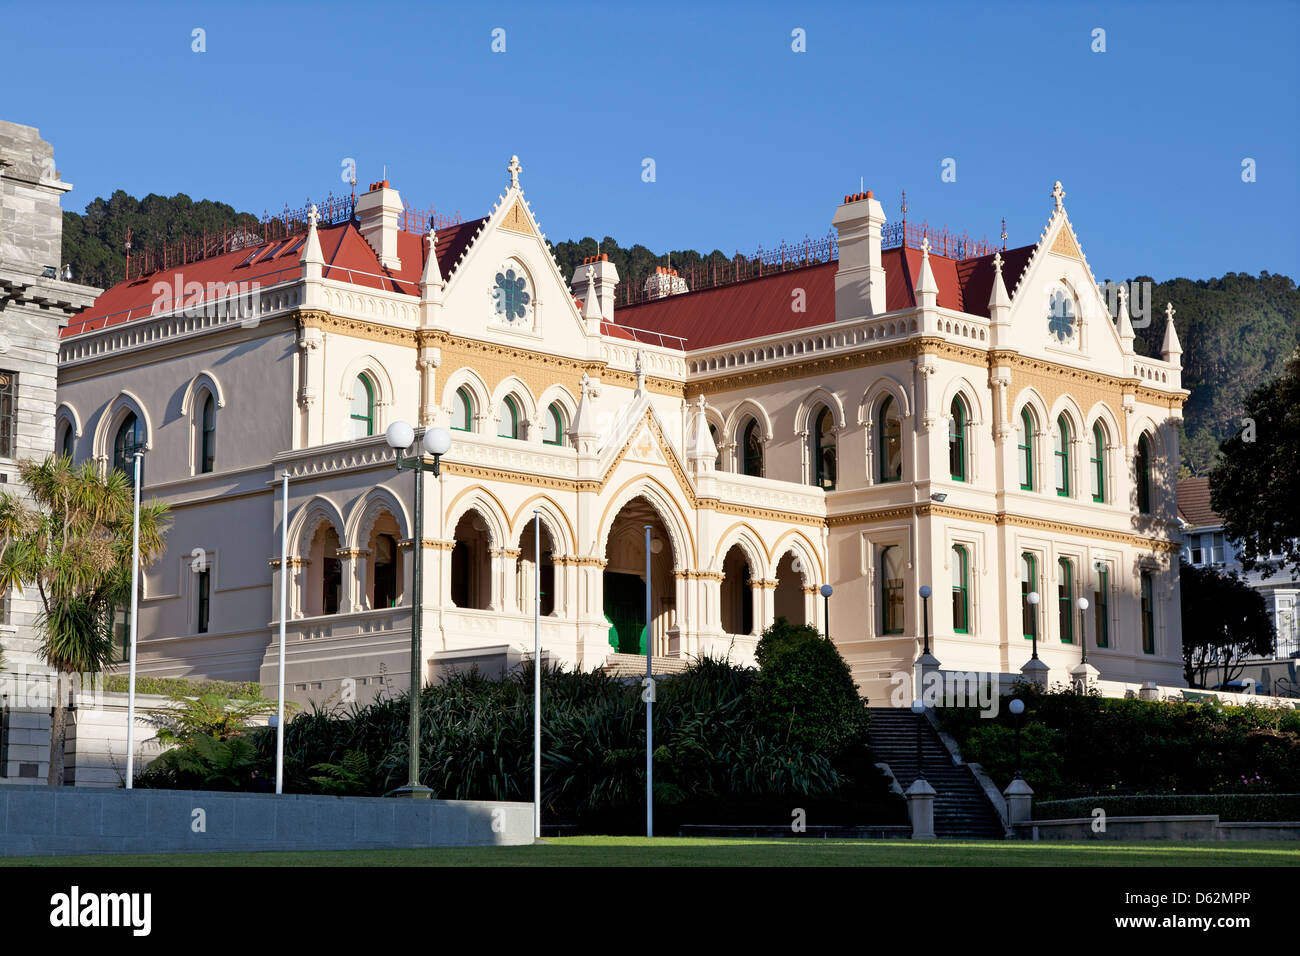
[{"xmin": 0, "ymin": 786, "xmax": 533, "ymax": 856}]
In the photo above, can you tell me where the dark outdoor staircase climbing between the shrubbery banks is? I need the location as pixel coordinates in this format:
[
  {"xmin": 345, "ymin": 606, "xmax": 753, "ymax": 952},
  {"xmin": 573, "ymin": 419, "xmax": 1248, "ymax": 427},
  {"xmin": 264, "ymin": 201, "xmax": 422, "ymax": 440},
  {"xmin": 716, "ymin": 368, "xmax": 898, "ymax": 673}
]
[{"xmin": 871, "ymin": 708, "xmax": 1006, "ymax": 840}]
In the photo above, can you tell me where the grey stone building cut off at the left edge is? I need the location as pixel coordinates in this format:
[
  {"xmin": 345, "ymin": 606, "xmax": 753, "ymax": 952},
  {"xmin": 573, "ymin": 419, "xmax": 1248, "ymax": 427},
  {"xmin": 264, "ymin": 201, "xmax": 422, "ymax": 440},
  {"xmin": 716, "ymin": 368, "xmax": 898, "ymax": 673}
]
[{"xmin": 0, "ymin": 121, "xmax": 100, "ymax": 784}]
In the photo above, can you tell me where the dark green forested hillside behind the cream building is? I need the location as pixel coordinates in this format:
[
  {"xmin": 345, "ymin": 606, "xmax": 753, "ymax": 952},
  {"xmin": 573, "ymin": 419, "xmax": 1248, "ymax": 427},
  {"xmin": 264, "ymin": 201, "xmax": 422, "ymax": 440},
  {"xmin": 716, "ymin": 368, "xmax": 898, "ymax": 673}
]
[{"xmin": 64, "ymin": 190, "xmax": 1300, "ymax": 475}]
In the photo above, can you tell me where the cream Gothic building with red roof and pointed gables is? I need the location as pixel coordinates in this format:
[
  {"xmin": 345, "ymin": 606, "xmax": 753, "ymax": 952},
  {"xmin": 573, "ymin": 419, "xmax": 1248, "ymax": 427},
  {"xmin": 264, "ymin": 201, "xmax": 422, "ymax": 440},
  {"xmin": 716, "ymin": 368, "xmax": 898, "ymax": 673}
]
[{"xmin": 50, "ymin": 160, "xmax": 1186, "ymax": 702}]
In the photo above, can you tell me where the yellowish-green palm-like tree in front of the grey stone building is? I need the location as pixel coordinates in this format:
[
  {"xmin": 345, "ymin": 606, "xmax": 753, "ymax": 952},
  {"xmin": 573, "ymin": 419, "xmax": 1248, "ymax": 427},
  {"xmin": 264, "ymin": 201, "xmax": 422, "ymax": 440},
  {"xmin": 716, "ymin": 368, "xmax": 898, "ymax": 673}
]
[{"xmin": 0, "ymin": 457, "xmax": 168, "ymax": 786}]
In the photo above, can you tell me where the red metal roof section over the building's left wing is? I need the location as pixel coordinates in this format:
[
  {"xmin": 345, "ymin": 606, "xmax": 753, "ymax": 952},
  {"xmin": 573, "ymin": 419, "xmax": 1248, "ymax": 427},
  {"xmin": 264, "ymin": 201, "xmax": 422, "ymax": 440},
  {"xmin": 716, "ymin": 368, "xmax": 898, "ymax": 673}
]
[{"xmin": 61, "ymin": 217, "xmax": 486, "ymax": 337}]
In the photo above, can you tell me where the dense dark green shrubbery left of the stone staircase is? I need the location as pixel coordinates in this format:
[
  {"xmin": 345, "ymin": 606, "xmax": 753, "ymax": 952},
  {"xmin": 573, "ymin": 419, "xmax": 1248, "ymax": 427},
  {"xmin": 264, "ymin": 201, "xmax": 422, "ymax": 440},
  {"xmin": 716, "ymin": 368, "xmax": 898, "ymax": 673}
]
[{"xmin": 138, "ymin": 659, "xmax": 906, "ymax": 832}]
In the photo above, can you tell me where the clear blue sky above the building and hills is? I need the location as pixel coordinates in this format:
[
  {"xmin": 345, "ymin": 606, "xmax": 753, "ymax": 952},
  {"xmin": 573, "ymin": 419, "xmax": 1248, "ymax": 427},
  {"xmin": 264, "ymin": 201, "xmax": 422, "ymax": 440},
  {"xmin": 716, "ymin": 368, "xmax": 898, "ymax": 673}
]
[{"xmin": 0, "ymin": 0, "xmax": 1300, "ymax": 280}]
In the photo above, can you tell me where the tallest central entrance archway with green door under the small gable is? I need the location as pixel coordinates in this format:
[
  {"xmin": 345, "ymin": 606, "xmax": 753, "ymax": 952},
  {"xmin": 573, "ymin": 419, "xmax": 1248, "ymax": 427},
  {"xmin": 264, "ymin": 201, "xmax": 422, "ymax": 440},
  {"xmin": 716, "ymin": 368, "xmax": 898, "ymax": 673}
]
[{"xmin": 605, "ymin": 497, "xmax": 677, "ymax": 654}]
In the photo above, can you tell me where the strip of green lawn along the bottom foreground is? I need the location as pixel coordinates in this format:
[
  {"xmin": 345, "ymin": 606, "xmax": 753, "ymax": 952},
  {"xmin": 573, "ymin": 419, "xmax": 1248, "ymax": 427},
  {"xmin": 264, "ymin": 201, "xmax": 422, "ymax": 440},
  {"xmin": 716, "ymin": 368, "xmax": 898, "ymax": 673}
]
[{"xmin": 0, "ymin": 836, "xmax": 1300, "ymax": 866}]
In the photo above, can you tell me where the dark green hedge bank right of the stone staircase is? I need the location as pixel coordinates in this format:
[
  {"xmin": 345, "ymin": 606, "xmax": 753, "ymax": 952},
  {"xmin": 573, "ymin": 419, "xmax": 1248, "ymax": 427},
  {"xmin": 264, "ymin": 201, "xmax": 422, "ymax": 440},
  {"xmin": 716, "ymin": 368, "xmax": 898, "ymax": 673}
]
[{"xmin": 939, "ymin": 687, "xmax": 1300, "ymax": 800}]
